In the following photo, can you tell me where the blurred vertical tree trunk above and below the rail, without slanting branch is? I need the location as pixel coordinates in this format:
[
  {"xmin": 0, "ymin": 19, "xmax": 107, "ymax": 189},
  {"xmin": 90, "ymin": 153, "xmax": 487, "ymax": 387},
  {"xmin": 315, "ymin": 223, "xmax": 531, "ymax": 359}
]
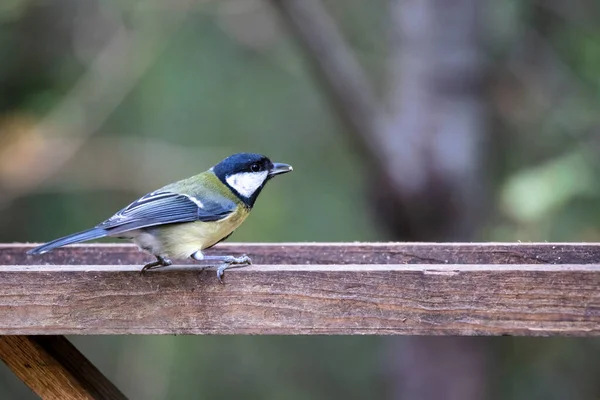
[{"xmin": 382, "ymin": 0, "xmax": 489, "ymax": 400}]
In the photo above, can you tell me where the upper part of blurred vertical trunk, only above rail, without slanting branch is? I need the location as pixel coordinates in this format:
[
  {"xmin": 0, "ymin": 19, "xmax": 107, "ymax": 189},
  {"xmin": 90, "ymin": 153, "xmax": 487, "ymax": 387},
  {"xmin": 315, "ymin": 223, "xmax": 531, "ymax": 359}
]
[{"xmin": 373, "ymin": 0, "xmax": 486, "ymax": 241}]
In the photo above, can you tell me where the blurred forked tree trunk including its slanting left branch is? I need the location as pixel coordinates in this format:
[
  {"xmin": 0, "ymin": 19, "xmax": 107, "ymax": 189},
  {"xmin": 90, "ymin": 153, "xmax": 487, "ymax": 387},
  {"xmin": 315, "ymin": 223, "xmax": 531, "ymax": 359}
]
[{"xmin": 272, "ymin": 0, "xmax": 488, "ymax": 400}]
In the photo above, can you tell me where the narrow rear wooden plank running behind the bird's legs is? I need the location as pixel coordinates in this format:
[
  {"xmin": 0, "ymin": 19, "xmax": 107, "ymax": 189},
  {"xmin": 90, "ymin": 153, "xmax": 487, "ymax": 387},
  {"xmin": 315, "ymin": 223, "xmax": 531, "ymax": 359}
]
[{"xmin": 0, "ymin": 242, "xmax": 600, "ymax": 265}]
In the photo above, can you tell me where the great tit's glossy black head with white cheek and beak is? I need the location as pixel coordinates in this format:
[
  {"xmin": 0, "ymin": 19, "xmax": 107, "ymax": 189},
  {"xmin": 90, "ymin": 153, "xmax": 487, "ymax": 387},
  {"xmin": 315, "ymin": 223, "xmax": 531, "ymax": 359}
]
[{"xmin": 212, "ymin": 153, "xmax": 292, "ymax": 207}]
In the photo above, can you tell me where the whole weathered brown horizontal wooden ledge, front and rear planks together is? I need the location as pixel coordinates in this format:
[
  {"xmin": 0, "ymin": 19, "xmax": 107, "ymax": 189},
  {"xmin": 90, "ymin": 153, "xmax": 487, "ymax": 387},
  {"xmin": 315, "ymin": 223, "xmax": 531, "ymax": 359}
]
[{"xmin": 0, "ymin": 243, "xmax": 600, "ymax": 336}]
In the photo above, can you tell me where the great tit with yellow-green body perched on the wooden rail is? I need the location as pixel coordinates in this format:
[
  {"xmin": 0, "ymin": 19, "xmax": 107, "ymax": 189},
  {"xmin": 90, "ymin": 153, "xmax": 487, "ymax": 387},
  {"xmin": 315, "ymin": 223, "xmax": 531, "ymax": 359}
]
[{"xmin": 27, "ymin": 153, "xmax": 292, "ymax": 283}]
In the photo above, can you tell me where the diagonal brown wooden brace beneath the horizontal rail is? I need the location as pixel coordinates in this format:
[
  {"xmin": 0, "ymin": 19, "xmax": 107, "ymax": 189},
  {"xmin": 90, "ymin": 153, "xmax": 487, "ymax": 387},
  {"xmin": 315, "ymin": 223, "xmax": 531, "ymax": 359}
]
[{"xmin": 0, "ymin": 336, "xmax": 126, "ymax": 400}]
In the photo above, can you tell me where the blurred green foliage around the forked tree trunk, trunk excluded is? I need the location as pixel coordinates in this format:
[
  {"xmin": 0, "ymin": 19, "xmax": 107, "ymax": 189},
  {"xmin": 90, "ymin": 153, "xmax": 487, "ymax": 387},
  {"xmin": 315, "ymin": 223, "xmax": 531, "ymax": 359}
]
[{"xmin": 0, "ymin": 0, "xmax": 600, "ymax": 399}]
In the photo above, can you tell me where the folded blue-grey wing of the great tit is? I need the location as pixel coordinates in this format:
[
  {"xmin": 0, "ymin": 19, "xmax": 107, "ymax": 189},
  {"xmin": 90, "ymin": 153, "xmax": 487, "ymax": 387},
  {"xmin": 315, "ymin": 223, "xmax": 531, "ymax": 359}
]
[{"xmin": 96, "ymin": 191, "xmax": 236, "ymax": 235}]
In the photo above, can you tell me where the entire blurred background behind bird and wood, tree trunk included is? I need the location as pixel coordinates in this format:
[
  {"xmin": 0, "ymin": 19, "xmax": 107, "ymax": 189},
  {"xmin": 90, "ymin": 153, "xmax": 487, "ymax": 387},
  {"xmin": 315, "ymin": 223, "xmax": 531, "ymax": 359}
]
[{"xmin": 0, "ymin": 0, "xmax": 600, "ymax": 400}]
